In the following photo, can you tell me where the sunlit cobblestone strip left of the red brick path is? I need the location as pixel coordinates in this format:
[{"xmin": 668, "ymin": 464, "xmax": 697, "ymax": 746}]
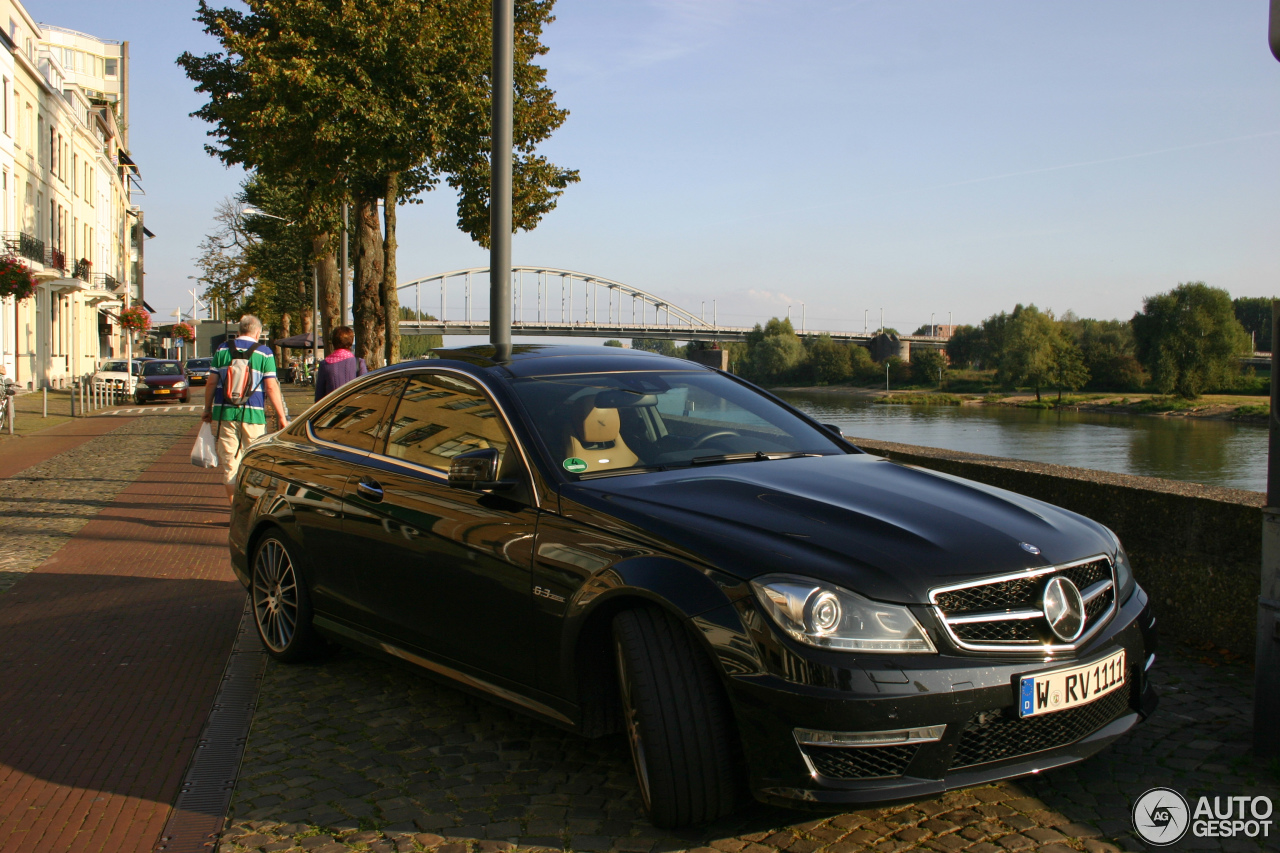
[{"xmin": 0, "ymin": 412, "xmax": 197, "ymax": 593}]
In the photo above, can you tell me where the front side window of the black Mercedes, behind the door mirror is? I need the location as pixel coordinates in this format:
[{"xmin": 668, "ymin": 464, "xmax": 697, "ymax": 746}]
[{"xmin": 387, "ymin": 373, "xmax": 511, "ymax": 473}]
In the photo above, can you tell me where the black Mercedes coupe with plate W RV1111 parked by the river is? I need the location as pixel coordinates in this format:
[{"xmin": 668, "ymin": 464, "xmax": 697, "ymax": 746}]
[{"xmin": 230, "ymin": 346, "xmax": 1156, "ymax": 826}]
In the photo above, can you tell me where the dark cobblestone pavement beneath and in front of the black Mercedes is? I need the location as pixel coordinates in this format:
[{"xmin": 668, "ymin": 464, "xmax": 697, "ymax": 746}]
[{"xmin": 221, "ymin": 651, "xmax": 1280, "ymax": 853}]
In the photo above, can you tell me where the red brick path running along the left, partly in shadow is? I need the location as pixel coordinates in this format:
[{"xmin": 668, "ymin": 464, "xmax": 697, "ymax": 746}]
[{"xmin": 0, "ymin": 416, "xmax": 244, "ymax": 853}]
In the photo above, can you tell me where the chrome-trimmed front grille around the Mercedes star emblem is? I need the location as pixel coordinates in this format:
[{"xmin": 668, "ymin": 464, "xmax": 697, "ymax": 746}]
[{"xmin": 929, "ymin": 556, "xmax": 1115, "ymax": 653}]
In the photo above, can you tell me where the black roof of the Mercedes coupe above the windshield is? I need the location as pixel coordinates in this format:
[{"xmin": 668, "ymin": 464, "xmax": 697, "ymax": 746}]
[{"xmin": 422, "ymin": 343, "xmax": 709, "ymax": 377}]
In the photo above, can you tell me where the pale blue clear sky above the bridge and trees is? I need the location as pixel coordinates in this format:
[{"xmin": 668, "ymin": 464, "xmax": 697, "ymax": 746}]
[{"xmin": 28, "ymin": 0, "xmax": 1280, "ymax": 330}]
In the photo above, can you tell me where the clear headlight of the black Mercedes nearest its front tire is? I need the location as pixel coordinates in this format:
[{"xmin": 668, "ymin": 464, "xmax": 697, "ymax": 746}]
[{"xmin": 751, "ymin": 575, "xmax": 937, "ymax": 652}]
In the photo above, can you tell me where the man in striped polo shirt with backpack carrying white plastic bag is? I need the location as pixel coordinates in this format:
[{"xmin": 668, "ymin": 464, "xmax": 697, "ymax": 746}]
[{"xmin": 204, "ymin": 314, "xmax": 289, "ymax": 501}]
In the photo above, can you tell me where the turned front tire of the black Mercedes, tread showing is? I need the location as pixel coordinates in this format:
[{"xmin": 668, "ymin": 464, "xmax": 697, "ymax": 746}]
[{"xmin": 613, "ymin": 607, "xmax": 739, "ymax": 827}]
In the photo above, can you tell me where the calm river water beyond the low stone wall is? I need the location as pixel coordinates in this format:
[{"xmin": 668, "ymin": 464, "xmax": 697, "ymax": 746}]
[{"xmin": 778, "ymin": 391, "xmax": 1267, "ymax": 492}]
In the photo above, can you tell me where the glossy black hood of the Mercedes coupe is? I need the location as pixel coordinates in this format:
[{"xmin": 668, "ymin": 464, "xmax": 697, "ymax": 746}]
[{"xmin": 562, "ymin": 455, "xmax": 1114, "ymax": 603}]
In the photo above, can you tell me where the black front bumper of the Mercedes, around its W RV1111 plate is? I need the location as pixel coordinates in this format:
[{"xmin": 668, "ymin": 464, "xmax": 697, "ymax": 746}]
[{"xmin": 728, "ymin": 581, "xmax": 1157, "ymax": 807}]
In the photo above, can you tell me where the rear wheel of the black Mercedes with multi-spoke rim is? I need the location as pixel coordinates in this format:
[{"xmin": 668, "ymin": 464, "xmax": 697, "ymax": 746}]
[{"xmin": 250, "ymin": 532, "xmax": 324, "ymax": 663}]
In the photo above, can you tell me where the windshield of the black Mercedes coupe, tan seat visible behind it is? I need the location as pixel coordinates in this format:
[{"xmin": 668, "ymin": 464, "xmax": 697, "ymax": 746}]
[{"xmin": 513, "ymin": 370, "xmax": 845, "ymax": 476}]
